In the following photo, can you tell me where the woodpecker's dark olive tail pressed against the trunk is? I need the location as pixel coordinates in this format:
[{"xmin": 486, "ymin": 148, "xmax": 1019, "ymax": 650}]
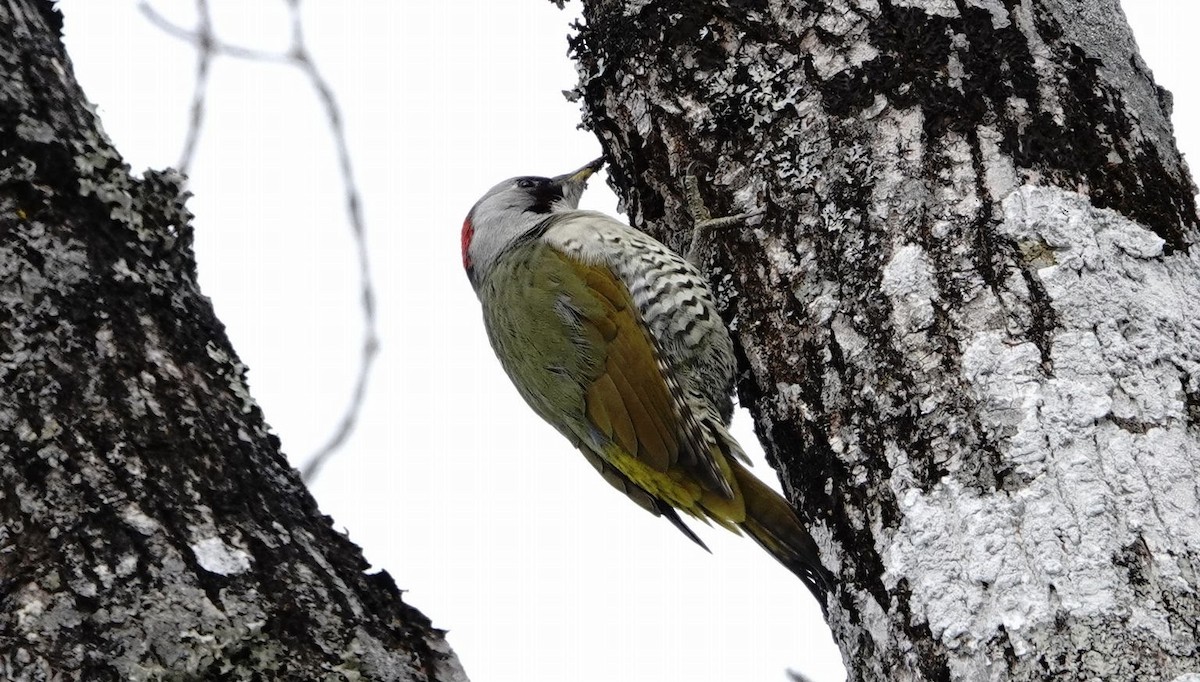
[{"xmin": 728, "ymin": 457, "xmax": 834, "ymax": 611}]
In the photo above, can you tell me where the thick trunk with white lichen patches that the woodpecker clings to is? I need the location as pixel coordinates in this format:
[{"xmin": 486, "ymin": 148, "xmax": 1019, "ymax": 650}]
[{"xmin": 572, "ymin": 0, "xmax": 1200, "ymax": 681}]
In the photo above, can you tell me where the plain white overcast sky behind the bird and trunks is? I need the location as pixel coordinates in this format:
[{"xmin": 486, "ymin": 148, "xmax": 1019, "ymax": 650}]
[{"xmin": 60, "ymin": 0, "xmax": 1200, "ymax": 682}]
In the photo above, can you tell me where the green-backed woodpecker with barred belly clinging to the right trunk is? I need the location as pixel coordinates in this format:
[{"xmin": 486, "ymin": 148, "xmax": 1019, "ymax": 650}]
[{"xmin": 462, "ymin": 158, "xmax": 833, "ymax": 608}]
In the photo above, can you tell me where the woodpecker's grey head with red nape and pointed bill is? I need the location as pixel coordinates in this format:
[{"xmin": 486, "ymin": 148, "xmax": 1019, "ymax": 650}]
[{"xmin": 462, "ymin": 157, "xmax": 604, "ymax": 286}]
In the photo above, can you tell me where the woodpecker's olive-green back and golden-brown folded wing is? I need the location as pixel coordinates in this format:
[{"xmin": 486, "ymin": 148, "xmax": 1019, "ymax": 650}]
[{"xmin": 480, "ymin": 241, "xmax": 745, "ymax": 528}]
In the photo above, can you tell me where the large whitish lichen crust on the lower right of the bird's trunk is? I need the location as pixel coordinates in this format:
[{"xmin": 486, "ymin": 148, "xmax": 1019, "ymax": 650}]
[{"xmin": 881, "ymin": 187, "xmax": 1200, "ymax": 678}]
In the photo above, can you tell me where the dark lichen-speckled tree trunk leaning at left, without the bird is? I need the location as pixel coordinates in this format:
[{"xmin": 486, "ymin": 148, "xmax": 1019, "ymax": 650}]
[{"xmin": 0, "ymin": 0, "xmax": 464, "ymax": 681}]
